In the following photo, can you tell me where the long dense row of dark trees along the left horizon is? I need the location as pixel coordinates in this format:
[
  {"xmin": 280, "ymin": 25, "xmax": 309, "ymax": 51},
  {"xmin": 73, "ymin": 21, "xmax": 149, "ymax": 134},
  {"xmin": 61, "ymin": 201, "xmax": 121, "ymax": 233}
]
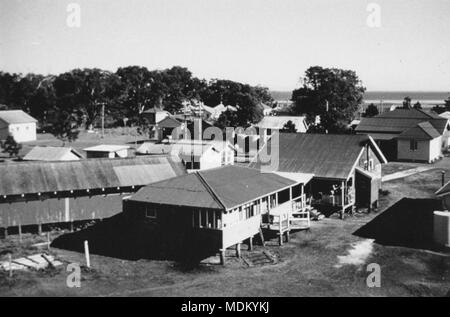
[{"xmin": 0, "ymin": 66, "xmax": 273, "ymax": 141}]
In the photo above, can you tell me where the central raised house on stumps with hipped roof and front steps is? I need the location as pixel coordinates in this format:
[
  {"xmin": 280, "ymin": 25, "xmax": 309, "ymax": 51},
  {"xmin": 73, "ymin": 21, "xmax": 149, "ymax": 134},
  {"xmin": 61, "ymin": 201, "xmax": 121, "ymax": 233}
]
[{"xmin": 123, "ymin": 165, "xmax": 312, "ymax": 263}]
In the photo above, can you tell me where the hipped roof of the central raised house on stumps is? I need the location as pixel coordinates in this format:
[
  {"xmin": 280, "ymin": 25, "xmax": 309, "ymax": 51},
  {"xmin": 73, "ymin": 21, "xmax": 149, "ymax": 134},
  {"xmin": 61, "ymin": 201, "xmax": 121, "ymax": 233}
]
[{"xmin": 131, "ymin": 165, "xmax": 297, "ymax": 210}]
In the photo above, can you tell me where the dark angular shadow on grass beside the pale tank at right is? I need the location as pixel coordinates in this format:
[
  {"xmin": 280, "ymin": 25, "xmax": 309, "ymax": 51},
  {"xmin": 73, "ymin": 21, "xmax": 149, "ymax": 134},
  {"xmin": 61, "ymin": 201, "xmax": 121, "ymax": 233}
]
[{"xmin": 353, "ymin": 198, "xmax": 442, "ymax": 251}]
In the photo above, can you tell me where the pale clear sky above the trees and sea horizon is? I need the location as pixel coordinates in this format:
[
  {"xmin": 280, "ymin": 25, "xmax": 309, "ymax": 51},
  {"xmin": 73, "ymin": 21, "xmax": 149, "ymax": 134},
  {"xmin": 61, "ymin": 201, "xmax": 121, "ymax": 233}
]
[{"xmin": 0, "ymin": 0, "xmax": 450, "ymax": 91}]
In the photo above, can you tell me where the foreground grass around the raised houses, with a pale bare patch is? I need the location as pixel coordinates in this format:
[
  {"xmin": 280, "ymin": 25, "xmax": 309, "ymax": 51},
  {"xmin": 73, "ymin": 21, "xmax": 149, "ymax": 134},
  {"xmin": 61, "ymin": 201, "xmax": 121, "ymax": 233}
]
[{"xmin": 0, "ymin": 158, "xmax": 450, "ymax": 296}]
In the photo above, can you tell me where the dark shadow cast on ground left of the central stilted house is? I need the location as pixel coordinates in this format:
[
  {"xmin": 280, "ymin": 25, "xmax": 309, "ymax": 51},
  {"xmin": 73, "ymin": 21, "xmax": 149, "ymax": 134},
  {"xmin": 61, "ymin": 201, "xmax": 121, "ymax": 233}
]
[{"xmin": 51, "ymin": 213, "xmax": 214, "ymax": 265}]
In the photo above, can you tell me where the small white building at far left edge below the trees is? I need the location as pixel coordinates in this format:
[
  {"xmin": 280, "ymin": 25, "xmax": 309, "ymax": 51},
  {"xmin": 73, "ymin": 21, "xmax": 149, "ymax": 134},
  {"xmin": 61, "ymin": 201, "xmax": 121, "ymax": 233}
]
[{"xmin": 0, "ymin": 110, "xmax": 37, "ymax": 142}]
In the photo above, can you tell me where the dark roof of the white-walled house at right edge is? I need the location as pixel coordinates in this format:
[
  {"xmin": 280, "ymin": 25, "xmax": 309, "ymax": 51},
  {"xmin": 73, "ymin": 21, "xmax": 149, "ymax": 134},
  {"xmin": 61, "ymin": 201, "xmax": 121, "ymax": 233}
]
[{"xmin": 355, "ymin": 109, "xmax": 448, "ymax": 134}]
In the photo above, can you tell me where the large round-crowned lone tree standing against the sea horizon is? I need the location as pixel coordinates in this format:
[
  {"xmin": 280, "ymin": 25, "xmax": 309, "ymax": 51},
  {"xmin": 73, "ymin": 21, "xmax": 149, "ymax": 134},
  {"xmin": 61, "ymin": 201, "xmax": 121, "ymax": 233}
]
[{"xmin": 291, "ymin": 66, "xmax": 365, "ymax": 130}]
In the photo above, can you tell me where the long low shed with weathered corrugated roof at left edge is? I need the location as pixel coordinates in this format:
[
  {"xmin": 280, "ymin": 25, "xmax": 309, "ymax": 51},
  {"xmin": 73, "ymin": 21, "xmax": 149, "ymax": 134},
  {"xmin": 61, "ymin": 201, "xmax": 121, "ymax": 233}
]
[{"xmin": 0, "ymin": 156, "xmax": 186, "ymax": 233}]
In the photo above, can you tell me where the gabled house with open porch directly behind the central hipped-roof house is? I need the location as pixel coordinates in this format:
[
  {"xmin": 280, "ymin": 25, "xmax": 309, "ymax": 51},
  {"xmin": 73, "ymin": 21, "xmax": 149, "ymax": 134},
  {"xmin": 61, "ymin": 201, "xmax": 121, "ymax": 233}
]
[{"xmin": 250, "ymin": 133, "xmax": 387, "ymax": 217}]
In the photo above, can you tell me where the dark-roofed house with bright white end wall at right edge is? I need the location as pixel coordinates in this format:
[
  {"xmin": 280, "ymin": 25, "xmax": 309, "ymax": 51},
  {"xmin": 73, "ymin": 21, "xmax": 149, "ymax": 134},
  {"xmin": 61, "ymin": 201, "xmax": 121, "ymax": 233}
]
[{"xmin": 355, "ymin": 109, "xmax": 450, "ymax": 163}]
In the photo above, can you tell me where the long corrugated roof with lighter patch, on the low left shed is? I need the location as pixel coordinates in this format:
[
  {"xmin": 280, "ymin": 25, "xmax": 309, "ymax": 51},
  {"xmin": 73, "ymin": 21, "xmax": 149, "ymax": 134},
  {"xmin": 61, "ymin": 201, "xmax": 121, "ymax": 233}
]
[{"xmin": 0, "ymin": 156, "xmax": 186, "ymax": 195}]
